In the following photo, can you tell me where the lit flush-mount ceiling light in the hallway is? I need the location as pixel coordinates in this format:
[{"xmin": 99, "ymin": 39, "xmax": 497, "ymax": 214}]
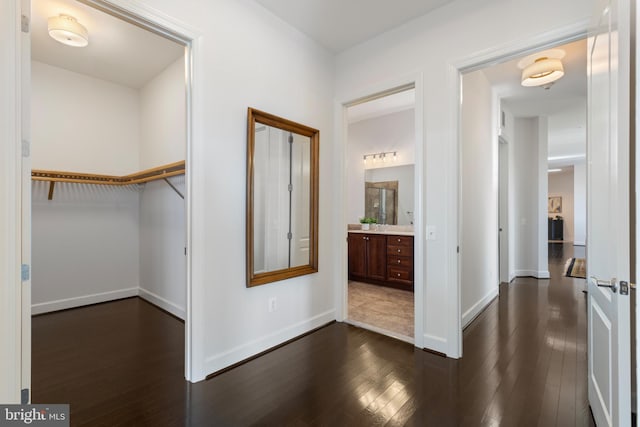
[{"xmin": 518, "ymin": 49, "xmax": 565, "ymax": 89}]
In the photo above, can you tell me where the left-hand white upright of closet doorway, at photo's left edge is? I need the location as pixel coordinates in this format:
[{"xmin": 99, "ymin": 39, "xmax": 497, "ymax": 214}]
[{"xmin": 0, "ymin": 0, "xmax": 23, "ymax": 403}]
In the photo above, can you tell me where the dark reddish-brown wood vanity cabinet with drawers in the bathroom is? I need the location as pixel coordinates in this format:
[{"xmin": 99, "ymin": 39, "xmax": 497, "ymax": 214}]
[{"xmin": 348, "ymin": 233, "xmax": 413, "ymax": 291}]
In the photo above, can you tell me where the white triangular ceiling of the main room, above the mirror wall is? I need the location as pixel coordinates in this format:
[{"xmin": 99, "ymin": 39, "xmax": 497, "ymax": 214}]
[{"xmin": 256, "ymin": 0, "xmax": 453, "ymax": 53}]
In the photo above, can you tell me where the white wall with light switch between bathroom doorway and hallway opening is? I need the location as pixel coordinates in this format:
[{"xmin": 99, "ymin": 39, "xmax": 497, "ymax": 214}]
[{"xmin": 333, "ymin": 0, "xmax": 591, "ymax": 355}]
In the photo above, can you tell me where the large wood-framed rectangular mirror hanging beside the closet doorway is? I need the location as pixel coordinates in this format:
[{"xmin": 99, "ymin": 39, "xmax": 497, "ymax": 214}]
[{"xmin": 247, "ymin": 108, "xmax": 320, "ymax": 287}]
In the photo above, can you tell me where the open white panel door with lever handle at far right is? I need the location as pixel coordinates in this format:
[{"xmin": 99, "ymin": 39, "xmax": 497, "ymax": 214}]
[{"xmin": 587, "ymin": 0, "xmax": 631, "ymax": 427}]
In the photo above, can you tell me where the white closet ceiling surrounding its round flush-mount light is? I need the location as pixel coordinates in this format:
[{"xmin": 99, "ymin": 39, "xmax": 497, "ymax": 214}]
[{"xmin": 31, "ymin": 0, "xmax": 184, "ymax": 88}]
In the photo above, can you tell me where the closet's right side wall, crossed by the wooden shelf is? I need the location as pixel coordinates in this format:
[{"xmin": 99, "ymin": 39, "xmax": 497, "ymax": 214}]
[{"xmin": 138, "ymin": 58, "xmax": 187, "ymax": 319}]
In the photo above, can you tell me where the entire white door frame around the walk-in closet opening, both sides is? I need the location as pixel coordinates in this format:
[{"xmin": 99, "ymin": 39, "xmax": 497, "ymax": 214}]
[{"xmin": 0, "ymin": 0, "xmax": 204, "ymax": 386}]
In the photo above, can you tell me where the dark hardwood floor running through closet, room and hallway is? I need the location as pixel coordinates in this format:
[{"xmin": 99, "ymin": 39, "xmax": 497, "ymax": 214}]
[{"xmin": 33, "ymin": 244, "xmax": 593, "ymax": 426}]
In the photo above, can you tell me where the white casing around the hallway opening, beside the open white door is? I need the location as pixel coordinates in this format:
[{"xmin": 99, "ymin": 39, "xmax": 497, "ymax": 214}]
[{"xmin": 447, "ymin": 20, "xmax": 589, "ymax": 357}]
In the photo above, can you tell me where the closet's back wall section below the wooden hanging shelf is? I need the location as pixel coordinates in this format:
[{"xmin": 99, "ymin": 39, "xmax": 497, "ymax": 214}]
[{"xmin": 31, "ymin": 181, "xmax": 139, "ymax": 314}]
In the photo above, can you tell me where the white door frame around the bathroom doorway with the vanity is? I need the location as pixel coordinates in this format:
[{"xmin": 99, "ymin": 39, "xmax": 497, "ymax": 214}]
[{"xmin": 333, "ymin": 74, "xmax": 426, "ymax": 348}]
